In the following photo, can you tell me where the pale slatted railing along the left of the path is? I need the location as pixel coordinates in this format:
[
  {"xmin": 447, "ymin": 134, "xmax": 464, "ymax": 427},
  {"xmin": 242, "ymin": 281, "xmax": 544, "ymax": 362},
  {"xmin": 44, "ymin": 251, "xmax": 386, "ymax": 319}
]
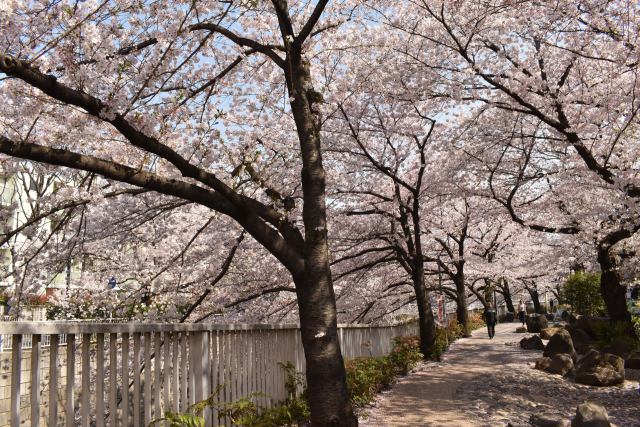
[{"xmin": 0, "ymin": 321, "xmax": 417, "ymax": 427}]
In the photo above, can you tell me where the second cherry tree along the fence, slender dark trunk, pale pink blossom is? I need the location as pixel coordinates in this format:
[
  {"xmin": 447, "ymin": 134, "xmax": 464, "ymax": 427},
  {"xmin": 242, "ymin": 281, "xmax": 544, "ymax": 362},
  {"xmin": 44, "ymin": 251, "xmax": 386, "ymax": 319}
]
[{"xmin": 329, "ymin": 92, "xmax": 435, "ymax": 357}]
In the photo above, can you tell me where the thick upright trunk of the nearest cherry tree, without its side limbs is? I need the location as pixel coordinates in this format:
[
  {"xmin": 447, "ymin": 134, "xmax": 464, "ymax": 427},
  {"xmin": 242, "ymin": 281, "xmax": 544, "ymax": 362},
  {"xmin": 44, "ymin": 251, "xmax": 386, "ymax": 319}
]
[{"xmin": 287, "ymin": 55, "xmax": 358, "ymax": 427}]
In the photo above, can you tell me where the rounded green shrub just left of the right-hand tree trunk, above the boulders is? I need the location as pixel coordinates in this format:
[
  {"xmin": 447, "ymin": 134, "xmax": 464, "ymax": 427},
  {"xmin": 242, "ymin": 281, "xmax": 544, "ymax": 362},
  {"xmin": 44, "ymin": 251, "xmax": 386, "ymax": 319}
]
[{"xmin": 560, "ymin": 271, "xmax": 605, "ymax": 316}]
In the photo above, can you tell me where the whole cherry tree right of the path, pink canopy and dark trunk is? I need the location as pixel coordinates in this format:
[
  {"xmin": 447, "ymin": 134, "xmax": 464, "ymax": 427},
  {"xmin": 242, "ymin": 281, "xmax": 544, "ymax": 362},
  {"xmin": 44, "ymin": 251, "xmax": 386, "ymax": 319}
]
[{"xmin": 381, "ymin": 1, "xmax": 640, "ymax": 334}]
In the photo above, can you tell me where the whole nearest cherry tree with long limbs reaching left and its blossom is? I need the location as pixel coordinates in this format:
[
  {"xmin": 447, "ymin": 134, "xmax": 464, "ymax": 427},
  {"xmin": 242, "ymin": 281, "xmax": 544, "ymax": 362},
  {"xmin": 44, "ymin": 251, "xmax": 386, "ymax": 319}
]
[{"xmin": 0, "ymin": 0, "xmax": 356, "ymax": 425}]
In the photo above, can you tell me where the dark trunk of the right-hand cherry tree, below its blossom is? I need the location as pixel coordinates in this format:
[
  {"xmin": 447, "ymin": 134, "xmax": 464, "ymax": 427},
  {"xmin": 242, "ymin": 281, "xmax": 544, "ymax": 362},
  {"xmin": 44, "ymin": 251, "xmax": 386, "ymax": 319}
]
[{"xmin": 598, "ymin": 246, "xmax": 637, "ymax": 338}]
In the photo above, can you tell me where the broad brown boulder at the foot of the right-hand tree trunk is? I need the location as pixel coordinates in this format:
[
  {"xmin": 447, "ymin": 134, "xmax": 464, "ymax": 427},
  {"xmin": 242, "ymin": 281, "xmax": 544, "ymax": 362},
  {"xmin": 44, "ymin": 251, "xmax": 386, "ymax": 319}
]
[{"xmin": 574, "ymin": 350, "xmax": 624, "ymax": 387}]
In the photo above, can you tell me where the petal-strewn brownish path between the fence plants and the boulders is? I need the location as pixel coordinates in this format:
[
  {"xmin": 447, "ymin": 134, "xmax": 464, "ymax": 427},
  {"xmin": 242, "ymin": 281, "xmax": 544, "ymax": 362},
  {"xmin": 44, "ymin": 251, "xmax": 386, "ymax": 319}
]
[{"xmin": 360, "ymin": 323, "xmax": 640, "ymax": 427}]
